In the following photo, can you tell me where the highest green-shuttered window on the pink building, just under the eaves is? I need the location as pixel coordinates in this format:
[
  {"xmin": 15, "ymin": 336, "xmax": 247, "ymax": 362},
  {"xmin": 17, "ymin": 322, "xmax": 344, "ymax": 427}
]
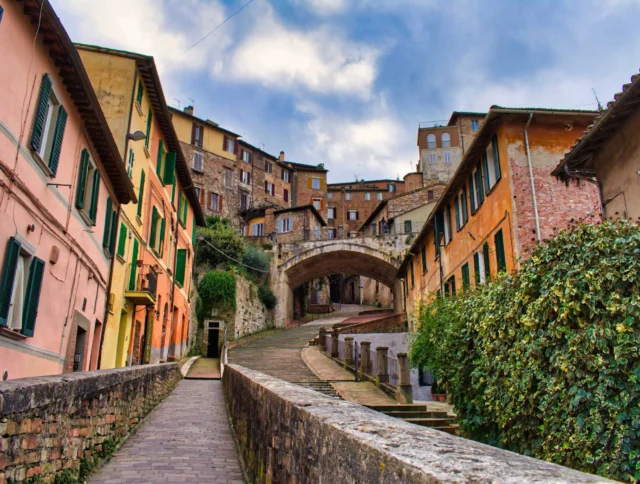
[{"xmin": 31, "ymin": 74, "xmax": 67, "ymax": 177}]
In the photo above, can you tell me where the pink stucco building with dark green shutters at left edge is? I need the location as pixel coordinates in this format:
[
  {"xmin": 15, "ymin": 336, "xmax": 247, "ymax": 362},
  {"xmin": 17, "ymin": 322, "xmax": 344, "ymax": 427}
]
[{"xmin": 0, "ymin": 0, "xmax": 135, "ymax": 379}]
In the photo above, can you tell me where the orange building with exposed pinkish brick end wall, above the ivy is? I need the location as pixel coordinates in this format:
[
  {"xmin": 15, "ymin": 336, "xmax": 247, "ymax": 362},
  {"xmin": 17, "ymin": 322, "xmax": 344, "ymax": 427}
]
[{"xmin": 398, "ymin": 106, "xmax": 599, "ymax": 329}]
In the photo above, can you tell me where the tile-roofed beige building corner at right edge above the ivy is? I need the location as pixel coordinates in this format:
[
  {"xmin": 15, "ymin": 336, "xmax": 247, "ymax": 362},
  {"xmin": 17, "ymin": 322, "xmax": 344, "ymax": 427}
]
[{"xmin": 553, "ymin": 74, "xmax": 640, "ymax": 223}]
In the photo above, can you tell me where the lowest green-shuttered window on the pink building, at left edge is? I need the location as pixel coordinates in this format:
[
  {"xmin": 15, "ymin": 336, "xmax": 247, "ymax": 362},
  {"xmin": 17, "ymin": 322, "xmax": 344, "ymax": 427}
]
[{"xmin": 0, "ymin": 237, "xmax": 45, "ymax": 336}]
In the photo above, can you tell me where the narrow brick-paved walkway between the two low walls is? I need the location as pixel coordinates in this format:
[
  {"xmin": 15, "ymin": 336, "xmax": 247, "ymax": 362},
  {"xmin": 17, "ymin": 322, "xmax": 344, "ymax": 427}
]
[{"xmin": 89, "ymin": 380, "xmax": 244, "ymax": 484}]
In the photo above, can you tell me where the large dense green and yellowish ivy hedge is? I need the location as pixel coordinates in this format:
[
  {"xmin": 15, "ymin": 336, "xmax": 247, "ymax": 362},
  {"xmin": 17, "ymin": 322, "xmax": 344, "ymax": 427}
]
[{"xmin": 410, "ymin": 221, "xmax": 640, "ymax": 481}]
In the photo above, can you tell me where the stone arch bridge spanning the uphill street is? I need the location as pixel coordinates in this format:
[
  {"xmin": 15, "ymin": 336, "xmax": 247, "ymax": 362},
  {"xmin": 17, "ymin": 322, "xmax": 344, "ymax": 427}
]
[{"xmin": 271, "ymin": 235, "xmax": 410, "ymax": 325}]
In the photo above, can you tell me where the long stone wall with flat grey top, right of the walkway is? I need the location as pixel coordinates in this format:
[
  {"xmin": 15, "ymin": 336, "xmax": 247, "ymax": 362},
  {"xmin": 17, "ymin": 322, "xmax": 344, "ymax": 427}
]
[{"xmin": 223, "ymin": 365, "xmax": 611, "ymax": 484}]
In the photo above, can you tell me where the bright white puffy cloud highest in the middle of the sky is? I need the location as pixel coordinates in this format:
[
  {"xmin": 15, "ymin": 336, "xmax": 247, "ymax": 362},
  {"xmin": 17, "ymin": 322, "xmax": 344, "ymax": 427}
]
[{"xmin": 222, "ymin": 8, "xmax": 380, "ymax": 99}]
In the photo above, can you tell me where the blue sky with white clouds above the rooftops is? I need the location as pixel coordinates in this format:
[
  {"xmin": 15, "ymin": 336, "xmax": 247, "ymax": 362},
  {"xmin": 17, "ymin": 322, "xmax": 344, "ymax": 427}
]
[{"xmin": 51, "ymin": 0, "xmax": 640, "ymax": 182}]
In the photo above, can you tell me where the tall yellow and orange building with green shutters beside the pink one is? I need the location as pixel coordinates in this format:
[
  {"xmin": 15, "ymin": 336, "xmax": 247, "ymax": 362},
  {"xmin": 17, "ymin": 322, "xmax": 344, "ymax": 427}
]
[{"xmin": 77, "ymin": 45, "xmax": 204, "ymax": 368}]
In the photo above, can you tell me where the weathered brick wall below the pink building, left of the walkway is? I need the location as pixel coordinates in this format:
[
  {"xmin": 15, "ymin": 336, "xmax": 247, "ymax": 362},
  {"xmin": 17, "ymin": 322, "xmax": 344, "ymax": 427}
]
[{"xmin": 0, "ymin": 363, "xmax": 181, "ymax": 484}]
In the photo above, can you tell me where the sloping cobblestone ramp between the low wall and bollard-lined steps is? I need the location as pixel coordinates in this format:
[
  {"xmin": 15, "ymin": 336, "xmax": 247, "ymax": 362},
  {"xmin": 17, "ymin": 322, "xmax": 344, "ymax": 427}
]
[{"xmin": 229, "ymin": 321, "xmax": 339, "ymax": 398}]
